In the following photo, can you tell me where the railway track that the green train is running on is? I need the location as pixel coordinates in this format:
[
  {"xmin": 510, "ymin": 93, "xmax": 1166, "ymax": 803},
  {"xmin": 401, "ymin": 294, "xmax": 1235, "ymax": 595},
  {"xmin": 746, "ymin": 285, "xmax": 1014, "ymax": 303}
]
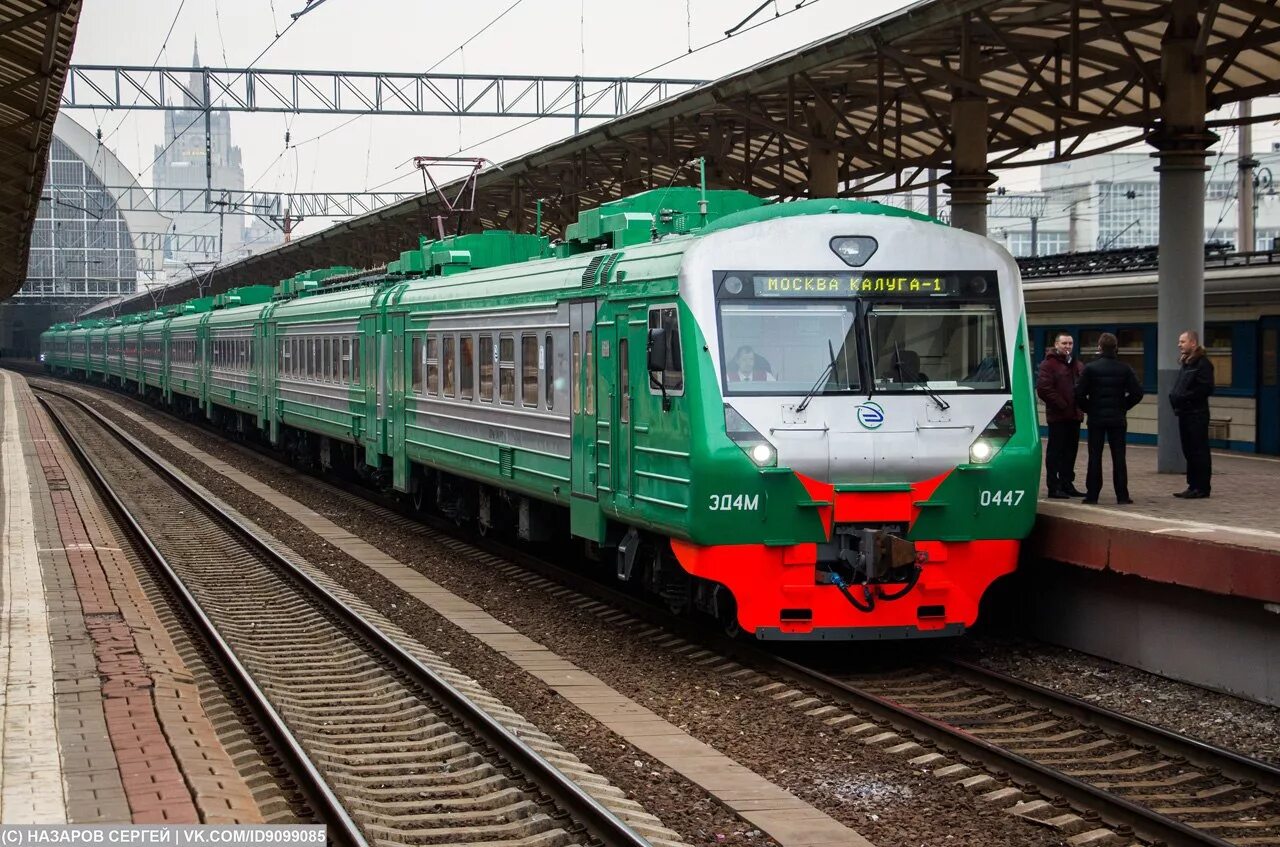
[{"xmin": 30, "ymin": 376, "xmax": 1280, "ymax": 847}]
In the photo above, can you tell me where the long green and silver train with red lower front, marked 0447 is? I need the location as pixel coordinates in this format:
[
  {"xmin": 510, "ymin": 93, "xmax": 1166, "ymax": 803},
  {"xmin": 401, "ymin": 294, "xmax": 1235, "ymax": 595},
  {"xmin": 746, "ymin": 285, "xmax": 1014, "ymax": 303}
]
[{"xmin": 40, "ymin": 188, "xmax": 1039, "ymax": 640}]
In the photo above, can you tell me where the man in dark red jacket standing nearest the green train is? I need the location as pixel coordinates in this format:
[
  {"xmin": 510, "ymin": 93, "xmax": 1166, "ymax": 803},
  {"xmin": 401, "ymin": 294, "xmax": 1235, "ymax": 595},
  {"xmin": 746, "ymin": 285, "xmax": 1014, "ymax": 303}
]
[{"xmin": 1036, "ymin": 333, "xmax": 1084, "ymax": 500}]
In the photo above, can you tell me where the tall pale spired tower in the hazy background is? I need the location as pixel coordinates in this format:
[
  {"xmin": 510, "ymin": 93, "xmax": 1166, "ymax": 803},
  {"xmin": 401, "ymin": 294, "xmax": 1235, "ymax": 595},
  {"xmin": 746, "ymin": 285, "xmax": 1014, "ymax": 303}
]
[{"xmin": 152, "ymin": 44, "xmax": 278, "ymax": 263}]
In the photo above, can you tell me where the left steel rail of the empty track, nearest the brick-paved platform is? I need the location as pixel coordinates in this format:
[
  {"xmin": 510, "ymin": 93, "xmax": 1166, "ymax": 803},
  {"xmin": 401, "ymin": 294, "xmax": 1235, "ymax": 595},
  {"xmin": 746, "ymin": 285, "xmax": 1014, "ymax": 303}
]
[{"xmin": 35, "ymin": 389, "xmax": 369, "ymax": 847}]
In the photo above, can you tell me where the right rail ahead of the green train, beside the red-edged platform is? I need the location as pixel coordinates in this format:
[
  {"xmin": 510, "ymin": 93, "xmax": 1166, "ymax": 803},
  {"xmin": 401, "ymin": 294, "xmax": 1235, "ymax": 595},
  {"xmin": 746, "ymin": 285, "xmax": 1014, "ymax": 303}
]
[{"xmin": 942, "ymin": 659, "xmax": 1280, "ymax": 789}]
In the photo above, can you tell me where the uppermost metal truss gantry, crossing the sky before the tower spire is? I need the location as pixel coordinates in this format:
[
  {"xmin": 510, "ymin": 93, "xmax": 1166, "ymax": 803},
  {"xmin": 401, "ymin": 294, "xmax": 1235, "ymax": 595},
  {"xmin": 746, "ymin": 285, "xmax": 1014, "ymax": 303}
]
[{"xmin": 61, "ymin": 65, "xmax": 704, "ymax": 127}]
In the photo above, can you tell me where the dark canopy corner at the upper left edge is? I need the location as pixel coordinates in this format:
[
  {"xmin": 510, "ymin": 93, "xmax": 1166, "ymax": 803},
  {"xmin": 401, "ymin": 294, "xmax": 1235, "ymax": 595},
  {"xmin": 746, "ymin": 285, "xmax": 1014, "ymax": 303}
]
[{"xmin": 0, "ymin": 0, "xmax": 81, "ymax": 299}]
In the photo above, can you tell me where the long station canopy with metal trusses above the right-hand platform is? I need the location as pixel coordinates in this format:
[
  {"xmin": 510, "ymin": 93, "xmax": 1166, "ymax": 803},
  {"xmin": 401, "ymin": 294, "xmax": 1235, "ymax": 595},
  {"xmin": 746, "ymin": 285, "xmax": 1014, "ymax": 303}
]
[{"xmin": 90, "ymin": 0, "xmax": 1280, "ymax": 317}]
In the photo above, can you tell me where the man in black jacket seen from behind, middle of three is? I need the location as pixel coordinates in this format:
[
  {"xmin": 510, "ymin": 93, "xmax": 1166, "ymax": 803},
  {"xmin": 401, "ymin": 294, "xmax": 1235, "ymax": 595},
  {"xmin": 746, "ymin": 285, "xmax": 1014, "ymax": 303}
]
[{"xmin": 1075, "ymin": 333, "xmax": 1142, "ymax": 505}]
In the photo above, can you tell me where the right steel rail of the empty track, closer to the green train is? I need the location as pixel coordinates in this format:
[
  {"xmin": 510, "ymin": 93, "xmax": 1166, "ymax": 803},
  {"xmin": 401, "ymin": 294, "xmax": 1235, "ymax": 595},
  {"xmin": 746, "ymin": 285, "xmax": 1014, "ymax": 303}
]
[{"xmin": 32, "ymin": 386, "xmax": 652, "ymax": 847}]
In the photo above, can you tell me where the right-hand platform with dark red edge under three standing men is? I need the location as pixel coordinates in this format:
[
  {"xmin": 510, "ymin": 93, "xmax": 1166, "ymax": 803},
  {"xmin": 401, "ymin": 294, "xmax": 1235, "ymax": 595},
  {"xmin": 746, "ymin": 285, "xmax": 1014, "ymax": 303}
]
[{"xmin": 1025, "ymin": 444, "xmax": 1280, "ymax": 603}]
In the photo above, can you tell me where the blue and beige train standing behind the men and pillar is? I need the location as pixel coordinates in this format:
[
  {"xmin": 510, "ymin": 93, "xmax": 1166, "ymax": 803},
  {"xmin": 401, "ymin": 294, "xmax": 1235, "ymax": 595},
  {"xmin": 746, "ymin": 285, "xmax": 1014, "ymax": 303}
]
[{"xmin": 1025, "ymin": 257, "xmax": 1280, "ymax": 454}]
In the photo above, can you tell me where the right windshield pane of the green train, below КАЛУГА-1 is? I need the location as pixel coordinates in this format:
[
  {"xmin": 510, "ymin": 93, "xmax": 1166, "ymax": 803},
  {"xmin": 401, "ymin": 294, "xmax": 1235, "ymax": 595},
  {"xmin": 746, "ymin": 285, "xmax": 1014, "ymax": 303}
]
[{"xmin": 867, "ymin": 303, "xmax": 1009, "ymax": 392}]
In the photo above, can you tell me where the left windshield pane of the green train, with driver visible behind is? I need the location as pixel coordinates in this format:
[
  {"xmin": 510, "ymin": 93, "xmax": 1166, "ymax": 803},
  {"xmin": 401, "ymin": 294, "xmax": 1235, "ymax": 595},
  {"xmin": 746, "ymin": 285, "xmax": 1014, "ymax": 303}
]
[{"xmin": 721, "ymin": 301, "xmax": 861, "ymax": 394}]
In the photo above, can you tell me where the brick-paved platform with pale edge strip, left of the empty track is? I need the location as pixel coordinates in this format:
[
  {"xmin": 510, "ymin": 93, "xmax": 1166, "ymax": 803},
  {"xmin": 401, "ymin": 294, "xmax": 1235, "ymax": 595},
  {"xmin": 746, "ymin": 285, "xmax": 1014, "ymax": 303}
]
[{"xmin": 0, "ymin": 371, "xmax": 262, "ymax": 824}]
